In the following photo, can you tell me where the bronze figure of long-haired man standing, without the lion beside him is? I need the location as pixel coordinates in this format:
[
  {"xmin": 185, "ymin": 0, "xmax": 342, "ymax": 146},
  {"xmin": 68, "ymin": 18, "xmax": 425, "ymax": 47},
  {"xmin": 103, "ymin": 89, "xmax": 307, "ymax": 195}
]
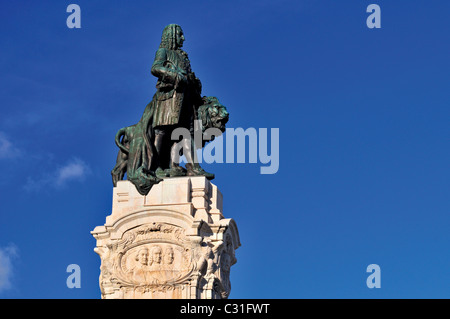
[{"xmin": 152, "ymin": 24, "xmax": 214, "ymax": 179}]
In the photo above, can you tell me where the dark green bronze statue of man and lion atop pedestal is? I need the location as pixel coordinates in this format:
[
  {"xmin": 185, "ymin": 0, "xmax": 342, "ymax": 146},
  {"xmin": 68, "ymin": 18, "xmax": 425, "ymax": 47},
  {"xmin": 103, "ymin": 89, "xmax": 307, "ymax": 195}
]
[{"xmin": 111, "ymin": 24, "xmax": 229, "ymax": 195}]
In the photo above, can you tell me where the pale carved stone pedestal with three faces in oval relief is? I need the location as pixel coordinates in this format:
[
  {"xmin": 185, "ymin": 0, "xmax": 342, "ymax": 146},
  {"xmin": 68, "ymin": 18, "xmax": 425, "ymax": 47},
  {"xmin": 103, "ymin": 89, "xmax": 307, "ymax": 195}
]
[{"xmin": 91, "ymin": 176, "xmax": 240, "ymax": 299}]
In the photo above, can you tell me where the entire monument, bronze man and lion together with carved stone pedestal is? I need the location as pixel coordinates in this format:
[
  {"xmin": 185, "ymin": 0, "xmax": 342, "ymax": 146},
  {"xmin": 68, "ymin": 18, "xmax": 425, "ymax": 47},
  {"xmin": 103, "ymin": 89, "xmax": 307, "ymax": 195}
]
[{"xmin": 91, "ymin": 24, "xmax": 240, "ymax": 299}]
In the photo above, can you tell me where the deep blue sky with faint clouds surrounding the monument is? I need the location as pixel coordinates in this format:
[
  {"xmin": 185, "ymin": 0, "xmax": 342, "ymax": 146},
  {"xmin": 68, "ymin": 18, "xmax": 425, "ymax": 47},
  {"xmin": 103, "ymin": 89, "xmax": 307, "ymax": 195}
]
[{"xmin": 0, "ymin": 0, "xmax": 450, "ymax": 298}]
